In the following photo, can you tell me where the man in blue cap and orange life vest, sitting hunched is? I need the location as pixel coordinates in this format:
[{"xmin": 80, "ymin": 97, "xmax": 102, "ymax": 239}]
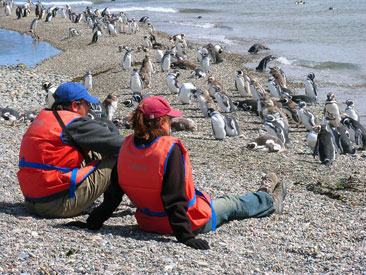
[{"xmin": 17, "ymin": 82, "xmax": 124, "ymax": 218}]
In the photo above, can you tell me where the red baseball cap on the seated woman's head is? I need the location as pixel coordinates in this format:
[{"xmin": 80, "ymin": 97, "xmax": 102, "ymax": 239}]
[{"xmin": 137, "ymin": 96, "xmax": 182, "ymax": 119}]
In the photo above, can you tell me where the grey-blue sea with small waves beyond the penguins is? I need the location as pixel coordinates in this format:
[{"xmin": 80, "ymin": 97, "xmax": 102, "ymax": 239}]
[{"xmin": 6, "ymin": 0, "xmax": 366, "ymax": 115}]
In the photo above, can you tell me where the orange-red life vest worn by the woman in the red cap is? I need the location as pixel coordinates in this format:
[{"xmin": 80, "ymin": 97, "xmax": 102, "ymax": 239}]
[{"xmin": 117, "ymin": 135, "xmax": 216, "ymax": 234}]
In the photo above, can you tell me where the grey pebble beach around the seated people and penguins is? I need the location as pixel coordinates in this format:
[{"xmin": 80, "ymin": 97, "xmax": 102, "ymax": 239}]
[{"xmin": 0, "ymin": 9, "xmax": 366, "ymax": 274}]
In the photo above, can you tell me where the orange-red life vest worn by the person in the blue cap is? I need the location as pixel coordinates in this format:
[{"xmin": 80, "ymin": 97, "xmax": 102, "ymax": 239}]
[{"xmin": 17, "ymin": 110, "xmax": 98, "ymax": 200}]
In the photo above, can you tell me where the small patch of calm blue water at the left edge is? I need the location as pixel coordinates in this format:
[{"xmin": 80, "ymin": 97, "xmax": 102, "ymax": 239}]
[{"xmin": 0, "ymin": 29, "xmax": 61, "ymax": 67}]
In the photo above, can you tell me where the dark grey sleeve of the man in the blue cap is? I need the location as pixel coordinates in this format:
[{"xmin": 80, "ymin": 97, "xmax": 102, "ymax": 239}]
[{"xmin": 62, "ymin": 116, "xmax": 124, "ymax": 156}]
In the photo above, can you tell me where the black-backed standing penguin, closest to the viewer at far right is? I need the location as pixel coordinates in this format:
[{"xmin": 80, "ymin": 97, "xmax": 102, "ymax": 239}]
[{"xmin": 313, "ymin": 124, "xmax": 336, "ymax": 166}]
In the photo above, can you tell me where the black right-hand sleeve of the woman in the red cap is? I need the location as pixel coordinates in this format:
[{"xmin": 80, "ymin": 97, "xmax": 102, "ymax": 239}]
[{"xmin": 161, "ymin": 144, "xmax": 195, "ymax": 242}]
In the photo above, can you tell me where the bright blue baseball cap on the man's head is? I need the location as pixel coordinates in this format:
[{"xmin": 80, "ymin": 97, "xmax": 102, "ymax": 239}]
[{"xmin": 55, "ymin": 82, "xmax": 99, "ymax": 104}]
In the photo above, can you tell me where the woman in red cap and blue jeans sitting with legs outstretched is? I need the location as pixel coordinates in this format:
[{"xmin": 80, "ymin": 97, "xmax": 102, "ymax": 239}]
[{"xmin": 68, "ymin": 96, "xmax": 286, "ymax": 249}]
